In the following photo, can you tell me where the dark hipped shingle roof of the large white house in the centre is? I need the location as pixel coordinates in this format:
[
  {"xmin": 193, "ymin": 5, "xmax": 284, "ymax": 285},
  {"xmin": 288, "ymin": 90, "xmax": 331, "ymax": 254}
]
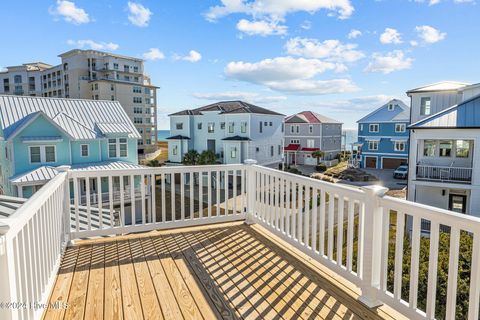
[{"xmin": 170, "ymin": 101, "xmax": 283, "ymax": 116}]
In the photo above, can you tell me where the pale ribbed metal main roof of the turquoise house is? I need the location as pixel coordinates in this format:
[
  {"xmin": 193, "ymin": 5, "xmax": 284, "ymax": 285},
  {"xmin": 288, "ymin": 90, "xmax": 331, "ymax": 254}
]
[{"xmin": 0, "ymin": 95, "xmax": 141, "ymax": 140}]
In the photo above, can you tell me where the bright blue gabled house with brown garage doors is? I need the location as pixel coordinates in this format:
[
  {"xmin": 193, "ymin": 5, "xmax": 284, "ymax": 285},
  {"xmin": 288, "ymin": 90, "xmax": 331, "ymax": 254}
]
[{"xmin": 356, "ymin": 99, "xmax": 410, "ymax": 169}]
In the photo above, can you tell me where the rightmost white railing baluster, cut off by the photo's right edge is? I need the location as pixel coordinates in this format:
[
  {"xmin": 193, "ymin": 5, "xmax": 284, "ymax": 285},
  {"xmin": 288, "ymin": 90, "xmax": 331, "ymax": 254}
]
[{"xmin": 468, "ymin": 228, "xmax": 480, "ymax": 320}]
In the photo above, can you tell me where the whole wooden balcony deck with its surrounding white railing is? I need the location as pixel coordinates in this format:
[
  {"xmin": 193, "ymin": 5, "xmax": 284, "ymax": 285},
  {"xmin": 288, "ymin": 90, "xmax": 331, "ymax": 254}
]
[{"xmin": 0, "ymin": 161, "xmax": 480, "ymax": 319}]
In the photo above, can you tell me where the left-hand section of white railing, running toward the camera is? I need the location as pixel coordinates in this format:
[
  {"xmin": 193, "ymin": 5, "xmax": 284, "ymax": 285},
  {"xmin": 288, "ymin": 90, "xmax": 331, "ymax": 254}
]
[{"xmin": 0, "ymin": 172, "xmax": 68, "ymax": 320}]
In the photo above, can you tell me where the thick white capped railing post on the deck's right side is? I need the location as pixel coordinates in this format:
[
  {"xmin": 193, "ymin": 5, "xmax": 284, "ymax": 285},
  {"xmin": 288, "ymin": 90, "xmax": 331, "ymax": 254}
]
[{"xmin": 360, "ymin": 185, "xmax": 388, "ymax": 308}]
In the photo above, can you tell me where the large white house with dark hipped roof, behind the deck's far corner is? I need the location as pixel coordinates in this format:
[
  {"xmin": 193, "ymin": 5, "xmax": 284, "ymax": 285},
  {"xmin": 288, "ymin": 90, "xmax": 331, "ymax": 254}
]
[{"xmin": 168, "ymin": 101, "xmax": 284, "ymax": 164}]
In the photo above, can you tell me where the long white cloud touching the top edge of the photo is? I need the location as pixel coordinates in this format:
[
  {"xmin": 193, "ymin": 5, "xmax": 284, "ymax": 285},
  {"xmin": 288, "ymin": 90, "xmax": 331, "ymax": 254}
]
[{"xmin": 205, "ymin": 0, "xmax": 354, "ymax": 21}]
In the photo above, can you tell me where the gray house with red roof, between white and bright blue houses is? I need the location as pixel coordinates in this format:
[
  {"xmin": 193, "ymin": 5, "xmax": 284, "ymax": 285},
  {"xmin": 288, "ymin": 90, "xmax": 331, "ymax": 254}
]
[{"xmin": 284, "ymin": 111, "xmax": 342, "ymax": 165}]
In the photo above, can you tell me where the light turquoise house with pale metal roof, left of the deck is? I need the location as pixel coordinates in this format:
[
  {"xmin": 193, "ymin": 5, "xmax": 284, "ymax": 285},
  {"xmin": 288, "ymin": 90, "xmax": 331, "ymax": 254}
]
[{"xmin": 0, "ymin": 95, "xmax": 141, "ymax": 197}]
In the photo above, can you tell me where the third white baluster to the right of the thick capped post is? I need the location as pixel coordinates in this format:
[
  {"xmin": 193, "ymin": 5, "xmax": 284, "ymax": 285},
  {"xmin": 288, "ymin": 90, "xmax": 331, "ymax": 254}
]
[{"xmin": 426, "ymin": 221, "xmax": 439, "ymax": 319}]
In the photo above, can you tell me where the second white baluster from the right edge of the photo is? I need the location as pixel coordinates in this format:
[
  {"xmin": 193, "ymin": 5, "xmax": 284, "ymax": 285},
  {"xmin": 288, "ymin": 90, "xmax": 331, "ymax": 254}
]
[{"xmin": 445, "ymin": 226, "xmax": 462, "ymax": 319}]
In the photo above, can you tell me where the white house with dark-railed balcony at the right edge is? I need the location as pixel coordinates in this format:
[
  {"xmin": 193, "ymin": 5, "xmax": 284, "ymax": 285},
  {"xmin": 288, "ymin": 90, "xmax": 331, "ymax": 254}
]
[{"xmin": 407, "ymin": 82, "xmax": 480, "ymax": 216}]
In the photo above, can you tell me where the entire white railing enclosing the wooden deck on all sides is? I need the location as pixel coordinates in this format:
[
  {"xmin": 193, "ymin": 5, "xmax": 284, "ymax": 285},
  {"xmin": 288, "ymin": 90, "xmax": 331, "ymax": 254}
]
[{"xmin": 0, "ymin": 160, "xmax": 480, "ymax": 319}]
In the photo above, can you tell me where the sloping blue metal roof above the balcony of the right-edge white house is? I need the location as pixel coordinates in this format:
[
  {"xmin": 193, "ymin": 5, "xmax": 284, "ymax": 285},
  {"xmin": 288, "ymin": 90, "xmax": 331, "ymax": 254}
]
[{"xmin": 409, "ymin": 95, "xmax": 480, "ymax": 129}]
